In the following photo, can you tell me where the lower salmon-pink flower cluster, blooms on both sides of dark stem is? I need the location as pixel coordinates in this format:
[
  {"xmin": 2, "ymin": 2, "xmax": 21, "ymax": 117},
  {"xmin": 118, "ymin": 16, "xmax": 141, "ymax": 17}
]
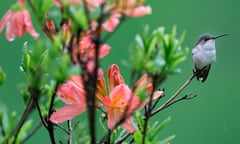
[{"xmin": 50, "ymin": 64, "xmax": 163, "ymax": 133}]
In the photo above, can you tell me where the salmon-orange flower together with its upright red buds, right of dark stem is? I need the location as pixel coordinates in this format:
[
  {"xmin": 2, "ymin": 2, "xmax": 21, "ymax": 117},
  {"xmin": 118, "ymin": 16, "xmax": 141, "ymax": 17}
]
[{"xmin": 97, "ymin": 64, "xmax": 163, "ymax": 133}]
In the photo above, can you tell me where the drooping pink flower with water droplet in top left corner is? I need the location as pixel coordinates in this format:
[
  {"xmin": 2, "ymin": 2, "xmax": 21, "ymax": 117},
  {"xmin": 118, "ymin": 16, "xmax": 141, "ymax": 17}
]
[{"xmin": 0, "ymin": 0, "xmax": 39, "ymax": 41}]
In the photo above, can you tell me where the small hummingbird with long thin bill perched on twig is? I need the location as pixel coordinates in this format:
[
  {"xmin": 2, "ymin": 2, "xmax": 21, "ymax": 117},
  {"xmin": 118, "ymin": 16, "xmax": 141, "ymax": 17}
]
[{"xmin": 192, "ymin": 34, "xmax": 228, "ymax": 82}]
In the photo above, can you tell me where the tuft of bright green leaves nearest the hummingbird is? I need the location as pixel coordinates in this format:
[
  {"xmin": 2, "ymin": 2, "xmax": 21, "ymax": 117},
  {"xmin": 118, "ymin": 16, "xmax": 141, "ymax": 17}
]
[{"xmin": 130, "ymin": 26, "xmax": 189, "ymax": 83}]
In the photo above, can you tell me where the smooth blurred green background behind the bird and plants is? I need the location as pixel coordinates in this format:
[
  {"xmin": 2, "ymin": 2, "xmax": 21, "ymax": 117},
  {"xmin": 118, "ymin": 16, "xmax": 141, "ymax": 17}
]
[{"xmin": 0, "ymin": 0, "xmax": 240, "ymax": 144}]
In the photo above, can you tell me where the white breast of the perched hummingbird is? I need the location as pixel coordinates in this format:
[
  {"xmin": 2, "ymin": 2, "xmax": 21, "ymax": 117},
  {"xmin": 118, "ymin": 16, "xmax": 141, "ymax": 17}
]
[{"xmin": 192, "ymin": 40, "xmax": 216, "ymax": 69}]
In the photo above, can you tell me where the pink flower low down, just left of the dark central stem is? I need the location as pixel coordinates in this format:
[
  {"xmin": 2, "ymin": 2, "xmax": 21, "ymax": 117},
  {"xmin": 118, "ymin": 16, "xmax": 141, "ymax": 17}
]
[{"xmin": 50, "ymin": 75, "xmax": 87, "ymax": 124}]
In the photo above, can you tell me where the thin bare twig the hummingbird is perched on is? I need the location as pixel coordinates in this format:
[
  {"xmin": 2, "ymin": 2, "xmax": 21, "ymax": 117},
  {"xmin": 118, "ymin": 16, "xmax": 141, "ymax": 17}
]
[{"xmin": 150, "ymin": 72, "xmax": 196, "ymax": 116}]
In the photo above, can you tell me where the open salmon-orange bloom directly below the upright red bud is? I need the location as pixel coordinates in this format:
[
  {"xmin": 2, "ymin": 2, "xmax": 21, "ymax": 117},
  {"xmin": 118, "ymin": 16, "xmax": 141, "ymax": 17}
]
[{"xmin": 102, "ymin": 84, "xmax": 140, "ymax": 133}]
